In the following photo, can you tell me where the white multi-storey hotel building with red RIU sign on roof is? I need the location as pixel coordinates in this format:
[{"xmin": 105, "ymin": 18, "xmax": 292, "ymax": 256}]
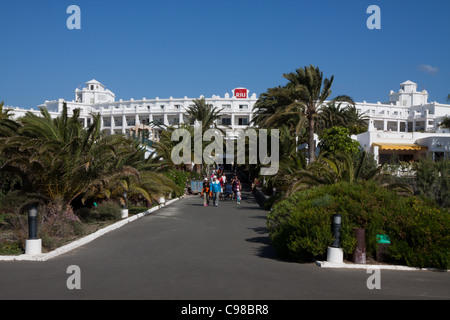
[{"xmin": 7, "ymin": 80, "xmax": 450, "ymax": 162}]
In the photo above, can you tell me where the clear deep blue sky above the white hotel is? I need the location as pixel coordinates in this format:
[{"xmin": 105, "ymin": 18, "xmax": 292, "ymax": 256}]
[{"xmin": 0, "ymin": 0, "xmax": 450, "ymax": 108}]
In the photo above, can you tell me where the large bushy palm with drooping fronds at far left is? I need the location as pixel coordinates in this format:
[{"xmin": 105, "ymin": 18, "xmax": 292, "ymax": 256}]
[{"xmin": 0, "ymin": 105, "xmax": 139, "ymax": 204}]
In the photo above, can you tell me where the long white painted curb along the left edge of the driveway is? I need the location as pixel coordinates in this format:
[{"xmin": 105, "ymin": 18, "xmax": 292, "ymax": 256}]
[{"xmin": 0, "ymin": 197, "xmax": 184, "ymax": 261}]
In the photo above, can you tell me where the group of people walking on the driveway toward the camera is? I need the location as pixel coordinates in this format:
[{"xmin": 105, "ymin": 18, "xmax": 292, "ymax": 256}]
[{"xmin": 201, "ymin": 170, "xmax": 242, "ymax": 207}]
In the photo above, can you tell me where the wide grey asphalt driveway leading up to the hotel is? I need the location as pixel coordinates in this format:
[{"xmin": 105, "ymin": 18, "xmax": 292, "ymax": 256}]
[{"xmin": 0, "ymin": 190, "xmax": 450, "ymax": 300}]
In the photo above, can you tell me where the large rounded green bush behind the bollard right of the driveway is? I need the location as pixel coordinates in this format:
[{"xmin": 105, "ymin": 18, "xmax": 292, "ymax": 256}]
[{"xmin": 267, "ymin": 182, "xmax": 450, "ymax": 269}]
